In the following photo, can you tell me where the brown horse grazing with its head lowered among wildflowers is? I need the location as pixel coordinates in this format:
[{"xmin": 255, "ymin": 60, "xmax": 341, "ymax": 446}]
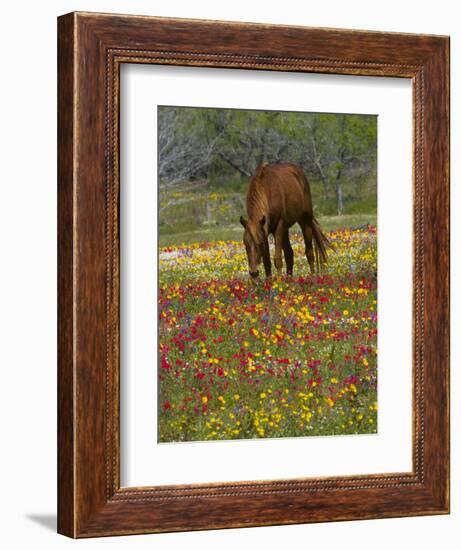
[{"xmin": 240, "ymin": 162, "xmax": 332, "ymax": 279}]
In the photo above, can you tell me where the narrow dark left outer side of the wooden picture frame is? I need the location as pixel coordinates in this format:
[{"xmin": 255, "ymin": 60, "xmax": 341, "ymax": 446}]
[{"xmin": 57, "ymin": 12, "xmax": 76, "ymax": 536}]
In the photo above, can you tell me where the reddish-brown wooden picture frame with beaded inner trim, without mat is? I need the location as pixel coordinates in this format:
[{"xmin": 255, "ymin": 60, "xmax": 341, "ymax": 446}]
[{"xmin": 58, "ymin": 13, "xmax": 449, "ymax": 537}]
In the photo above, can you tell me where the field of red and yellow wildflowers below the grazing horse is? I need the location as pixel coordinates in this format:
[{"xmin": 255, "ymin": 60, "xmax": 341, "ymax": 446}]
[{"xmin": 158, "ymin": 226, "xmax": 377, "ymax": 442}]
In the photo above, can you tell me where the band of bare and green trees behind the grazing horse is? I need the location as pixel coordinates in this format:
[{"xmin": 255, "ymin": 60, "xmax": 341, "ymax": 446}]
[{"xmin": 158, "ymin": 107, "xmax": 377, "ymax": 219}]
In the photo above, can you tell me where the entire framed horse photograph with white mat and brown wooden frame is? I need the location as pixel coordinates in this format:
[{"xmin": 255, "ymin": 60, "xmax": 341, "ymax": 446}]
[{"xmin": 58, "ymin": 13, "xmax": 449, "ymax": 538}]
